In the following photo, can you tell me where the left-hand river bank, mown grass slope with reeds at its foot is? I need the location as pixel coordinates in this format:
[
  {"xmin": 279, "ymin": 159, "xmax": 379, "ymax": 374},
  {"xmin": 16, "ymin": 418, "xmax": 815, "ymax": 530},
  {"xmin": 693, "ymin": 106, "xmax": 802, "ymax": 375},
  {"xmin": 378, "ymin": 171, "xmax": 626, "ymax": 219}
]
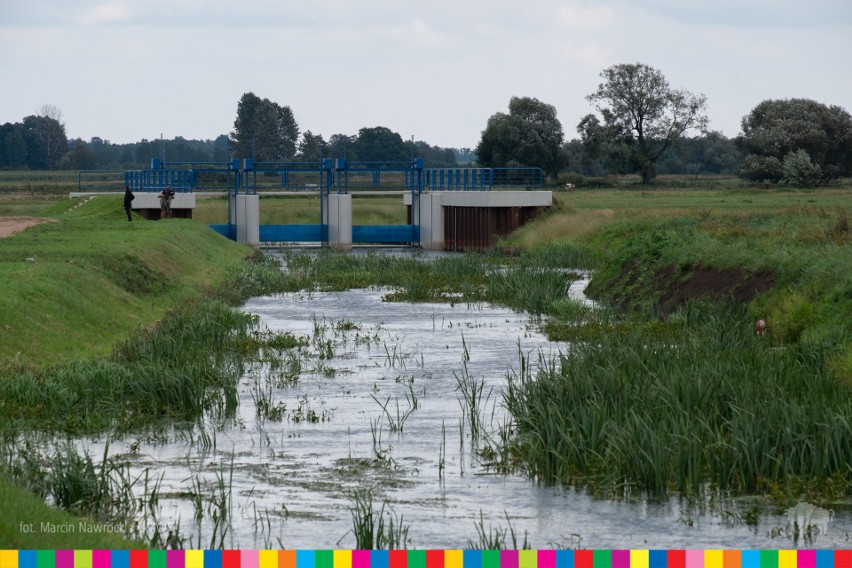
[{"xmin": 0, "ymin": 196, "xmax": 260, "ymax": 549}]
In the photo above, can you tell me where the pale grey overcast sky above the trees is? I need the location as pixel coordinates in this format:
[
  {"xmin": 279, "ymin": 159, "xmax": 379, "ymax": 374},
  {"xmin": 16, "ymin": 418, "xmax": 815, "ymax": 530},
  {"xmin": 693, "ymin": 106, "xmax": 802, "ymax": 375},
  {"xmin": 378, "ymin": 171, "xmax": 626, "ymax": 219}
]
[{"xmin": 0, "ymin": 0, "xmax": 852, "ymax": 147}]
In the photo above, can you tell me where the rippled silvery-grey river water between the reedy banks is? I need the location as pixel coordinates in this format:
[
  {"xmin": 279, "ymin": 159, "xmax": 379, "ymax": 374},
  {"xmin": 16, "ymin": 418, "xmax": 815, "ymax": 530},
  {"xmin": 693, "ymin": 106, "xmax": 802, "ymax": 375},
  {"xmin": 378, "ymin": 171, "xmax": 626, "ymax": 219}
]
[{"xmin": 83, "ymin": 283, "xmax": 852, "ymax": 549}]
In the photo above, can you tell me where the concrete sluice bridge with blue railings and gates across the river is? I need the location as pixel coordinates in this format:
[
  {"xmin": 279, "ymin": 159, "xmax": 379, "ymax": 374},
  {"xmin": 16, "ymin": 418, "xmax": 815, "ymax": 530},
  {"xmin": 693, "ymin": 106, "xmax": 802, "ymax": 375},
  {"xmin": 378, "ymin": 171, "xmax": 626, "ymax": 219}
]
[{"xmin": 78, "ymin": 158, "xmax": 551, "ymax": 250}]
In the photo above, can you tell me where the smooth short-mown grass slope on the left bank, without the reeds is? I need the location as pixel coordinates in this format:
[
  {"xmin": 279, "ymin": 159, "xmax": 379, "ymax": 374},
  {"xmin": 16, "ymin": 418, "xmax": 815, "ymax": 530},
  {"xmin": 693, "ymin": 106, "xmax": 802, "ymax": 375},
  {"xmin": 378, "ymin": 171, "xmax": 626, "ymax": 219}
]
[{"xmin": 0, "ymin": 196, "xmax": 250, "ymax": 367}]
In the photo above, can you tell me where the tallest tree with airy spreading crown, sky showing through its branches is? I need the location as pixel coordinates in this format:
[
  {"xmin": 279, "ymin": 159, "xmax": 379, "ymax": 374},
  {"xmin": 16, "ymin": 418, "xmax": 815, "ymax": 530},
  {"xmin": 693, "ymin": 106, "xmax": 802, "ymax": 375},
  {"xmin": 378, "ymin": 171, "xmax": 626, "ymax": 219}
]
[{"xmin": 577, "ymin": 63, "xmax": 708, "ymax": 183}]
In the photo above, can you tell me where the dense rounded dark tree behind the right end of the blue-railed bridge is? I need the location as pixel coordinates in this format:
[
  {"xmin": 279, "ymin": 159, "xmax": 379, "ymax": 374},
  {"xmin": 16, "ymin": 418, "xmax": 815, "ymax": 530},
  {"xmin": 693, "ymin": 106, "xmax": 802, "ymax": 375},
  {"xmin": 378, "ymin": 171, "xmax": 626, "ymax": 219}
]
[{"xmin": 476, "ymin": 97, "xmax": 564, "ymax": 178}]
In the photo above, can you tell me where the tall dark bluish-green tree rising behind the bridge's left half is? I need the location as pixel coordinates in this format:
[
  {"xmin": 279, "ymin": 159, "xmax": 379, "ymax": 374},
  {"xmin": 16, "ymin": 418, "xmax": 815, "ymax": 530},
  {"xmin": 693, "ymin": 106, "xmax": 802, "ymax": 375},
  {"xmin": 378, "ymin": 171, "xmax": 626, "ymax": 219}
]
[{"xmin": 231, "ymin": 93, "xmax": 299, "ymax": 162}]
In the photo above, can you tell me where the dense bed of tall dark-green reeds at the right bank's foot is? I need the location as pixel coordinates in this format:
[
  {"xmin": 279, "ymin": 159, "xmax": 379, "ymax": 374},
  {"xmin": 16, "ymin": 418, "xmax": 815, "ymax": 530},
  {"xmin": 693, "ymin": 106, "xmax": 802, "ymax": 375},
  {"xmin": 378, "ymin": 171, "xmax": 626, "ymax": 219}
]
[{"xmin": 504, "ymin": 304, "xmax": 852, "ymax": 493}]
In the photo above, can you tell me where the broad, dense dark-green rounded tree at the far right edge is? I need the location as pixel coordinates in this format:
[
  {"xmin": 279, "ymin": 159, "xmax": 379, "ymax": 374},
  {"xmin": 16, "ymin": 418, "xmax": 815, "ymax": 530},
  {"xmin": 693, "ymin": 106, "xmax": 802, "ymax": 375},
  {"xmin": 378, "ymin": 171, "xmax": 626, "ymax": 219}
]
[{"xmin": 739, "ymin": 99, "xmax": 852, "ymax": 182}]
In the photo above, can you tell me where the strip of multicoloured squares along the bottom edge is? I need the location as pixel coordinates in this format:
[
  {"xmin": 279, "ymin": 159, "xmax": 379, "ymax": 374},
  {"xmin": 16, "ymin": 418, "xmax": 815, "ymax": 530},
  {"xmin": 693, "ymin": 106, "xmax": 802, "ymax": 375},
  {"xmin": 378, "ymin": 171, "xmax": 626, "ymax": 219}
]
[{"xmin": 0, "ymin": 550, "xmax": 852, "ymax": 568}]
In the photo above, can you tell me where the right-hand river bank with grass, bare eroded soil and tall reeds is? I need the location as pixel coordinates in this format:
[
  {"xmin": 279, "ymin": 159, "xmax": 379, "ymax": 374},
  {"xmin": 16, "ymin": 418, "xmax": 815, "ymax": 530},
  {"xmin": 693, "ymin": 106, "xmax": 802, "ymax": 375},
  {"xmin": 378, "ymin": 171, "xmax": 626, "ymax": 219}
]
[{"xmin": 502, "ymin": 188, "xmax": 852, "ymax": 496}]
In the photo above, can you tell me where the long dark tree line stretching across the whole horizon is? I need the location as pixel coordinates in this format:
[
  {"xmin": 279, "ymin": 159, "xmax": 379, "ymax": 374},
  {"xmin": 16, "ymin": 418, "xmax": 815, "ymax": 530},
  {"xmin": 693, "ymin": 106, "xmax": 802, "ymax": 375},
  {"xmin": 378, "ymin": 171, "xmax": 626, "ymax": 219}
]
[{"xmin": 6, "ymin": 63, "xmax": 852, "ymax": 186}]
